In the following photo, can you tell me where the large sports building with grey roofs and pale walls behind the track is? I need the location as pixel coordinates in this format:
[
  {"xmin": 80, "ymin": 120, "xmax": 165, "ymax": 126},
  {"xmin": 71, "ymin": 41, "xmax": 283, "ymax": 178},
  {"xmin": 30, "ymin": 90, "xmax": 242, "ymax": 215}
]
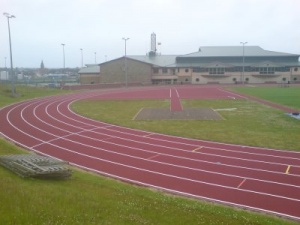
[{"xmin": 100, "ymin": 46, "xmax": 300, "ymax": 84}]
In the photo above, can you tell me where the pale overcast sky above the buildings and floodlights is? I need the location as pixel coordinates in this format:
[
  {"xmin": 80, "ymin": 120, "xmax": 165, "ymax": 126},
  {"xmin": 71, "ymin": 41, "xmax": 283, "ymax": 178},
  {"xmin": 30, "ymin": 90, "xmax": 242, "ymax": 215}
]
[{"xmin": 0, "ymin": 0, "xmax": 300, "ymax": 68}]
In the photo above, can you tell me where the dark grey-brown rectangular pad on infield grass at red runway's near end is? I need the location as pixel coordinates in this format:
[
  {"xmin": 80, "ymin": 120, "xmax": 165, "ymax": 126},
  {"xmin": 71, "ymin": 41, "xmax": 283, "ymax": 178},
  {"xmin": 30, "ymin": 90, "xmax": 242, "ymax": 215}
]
[{"xmin": 133, "ymin": 108, "xmax": 223, "ymax": 120}]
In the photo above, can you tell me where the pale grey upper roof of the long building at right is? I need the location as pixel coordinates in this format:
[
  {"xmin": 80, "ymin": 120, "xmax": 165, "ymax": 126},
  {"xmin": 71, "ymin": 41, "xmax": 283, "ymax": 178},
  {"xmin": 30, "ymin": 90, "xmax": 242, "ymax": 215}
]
[{"xmin": 178, "ymin": 46, "xmax": 299, "ymax": 58}]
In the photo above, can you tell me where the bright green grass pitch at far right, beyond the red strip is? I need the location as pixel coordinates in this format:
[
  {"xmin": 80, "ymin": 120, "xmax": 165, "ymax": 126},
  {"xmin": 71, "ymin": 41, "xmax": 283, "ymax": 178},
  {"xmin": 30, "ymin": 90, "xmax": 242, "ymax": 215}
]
[{"xmin": 232, "ymin": 86, "xmax": 300, "ymax": 110}]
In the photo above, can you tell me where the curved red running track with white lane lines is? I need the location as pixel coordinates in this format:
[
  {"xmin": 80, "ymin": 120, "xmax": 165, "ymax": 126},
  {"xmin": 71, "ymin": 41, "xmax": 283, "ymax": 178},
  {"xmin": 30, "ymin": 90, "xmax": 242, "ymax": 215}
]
[{"xmin": 0, "ymin": 86, "xmax": 300, "ymax": 220}]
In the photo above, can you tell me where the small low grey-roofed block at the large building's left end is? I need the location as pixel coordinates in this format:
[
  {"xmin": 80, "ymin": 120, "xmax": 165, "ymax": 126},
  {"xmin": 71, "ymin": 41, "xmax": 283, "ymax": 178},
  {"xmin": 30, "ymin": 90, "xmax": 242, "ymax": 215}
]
[{"xmin": 78, "ymin": 64, "xmax": 101, "ymax": 84}]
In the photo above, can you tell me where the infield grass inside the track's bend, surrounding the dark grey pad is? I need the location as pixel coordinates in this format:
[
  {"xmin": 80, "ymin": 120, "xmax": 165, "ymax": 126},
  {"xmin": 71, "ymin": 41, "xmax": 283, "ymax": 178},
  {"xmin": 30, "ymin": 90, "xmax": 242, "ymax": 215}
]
[{"xmin": 72, "ymin": 99, "xmax": 300, "ymax": 151}]
